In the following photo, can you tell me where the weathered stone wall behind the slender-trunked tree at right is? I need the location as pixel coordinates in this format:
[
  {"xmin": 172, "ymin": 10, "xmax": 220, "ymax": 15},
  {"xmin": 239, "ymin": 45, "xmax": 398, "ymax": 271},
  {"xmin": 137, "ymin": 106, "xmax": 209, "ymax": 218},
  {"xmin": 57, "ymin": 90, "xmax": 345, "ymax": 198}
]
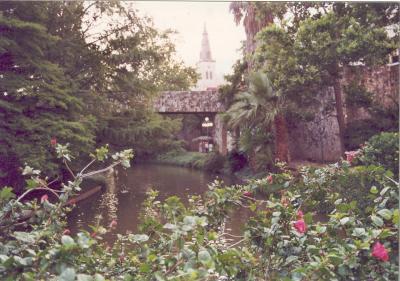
[{"xmin": 290, "ymin": 64, "xmax": 399, "ymax": 162}]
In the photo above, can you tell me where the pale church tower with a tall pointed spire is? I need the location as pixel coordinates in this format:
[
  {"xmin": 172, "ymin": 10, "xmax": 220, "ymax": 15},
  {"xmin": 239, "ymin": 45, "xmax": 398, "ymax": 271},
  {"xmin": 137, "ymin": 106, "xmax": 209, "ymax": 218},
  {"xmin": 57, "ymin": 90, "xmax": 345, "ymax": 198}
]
[{"xmin": 196, "ymin": 24, "xmax": 217, "ymax": 91}]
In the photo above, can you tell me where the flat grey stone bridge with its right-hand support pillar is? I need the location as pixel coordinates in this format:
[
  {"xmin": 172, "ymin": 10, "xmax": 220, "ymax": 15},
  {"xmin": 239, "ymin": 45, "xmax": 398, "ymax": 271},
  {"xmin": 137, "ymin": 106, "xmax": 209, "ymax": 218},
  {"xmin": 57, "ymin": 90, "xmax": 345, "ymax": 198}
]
[{"xmin": 154, "ymin": 90, "xmax": 227, "ymax": 155}]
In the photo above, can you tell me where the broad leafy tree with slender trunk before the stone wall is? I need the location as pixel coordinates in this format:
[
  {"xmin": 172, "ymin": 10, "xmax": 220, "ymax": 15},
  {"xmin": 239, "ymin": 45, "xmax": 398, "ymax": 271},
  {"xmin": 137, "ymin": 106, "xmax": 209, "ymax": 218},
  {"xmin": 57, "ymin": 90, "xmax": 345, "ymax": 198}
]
[{"xmin": 253, "ymin": 3, "xmax": 398, "ymax": 153}]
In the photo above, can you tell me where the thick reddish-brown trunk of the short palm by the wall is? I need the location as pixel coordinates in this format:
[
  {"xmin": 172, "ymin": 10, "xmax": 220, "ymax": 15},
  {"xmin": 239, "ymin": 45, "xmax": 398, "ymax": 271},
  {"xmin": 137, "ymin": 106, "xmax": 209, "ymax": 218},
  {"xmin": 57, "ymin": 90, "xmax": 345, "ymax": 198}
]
[{"xmin": 274, "ymin": 114, "xmax": 290, "ymax": 163}]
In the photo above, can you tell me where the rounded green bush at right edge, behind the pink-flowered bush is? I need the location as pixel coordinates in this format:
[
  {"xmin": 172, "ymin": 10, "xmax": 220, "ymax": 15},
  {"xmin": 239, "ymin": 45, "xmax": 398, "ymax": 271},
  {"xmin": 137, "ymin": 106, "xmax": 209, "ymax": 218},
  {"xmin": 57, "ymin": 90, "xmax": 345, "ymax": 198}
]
[{"xmin": 359, "ymin": 132, "xmax": 399, "ymax": 177}]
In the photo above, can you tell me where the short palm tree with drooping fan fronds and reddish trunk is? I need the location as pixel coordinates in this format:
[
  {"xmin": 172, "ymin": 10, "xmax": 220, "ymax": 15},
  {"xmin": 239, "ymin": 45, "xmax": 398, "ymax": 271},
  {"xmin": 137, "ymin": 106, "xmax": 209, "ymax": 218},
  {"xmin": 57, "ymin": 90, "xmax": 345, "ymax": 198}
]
[{"xmin": 226, "ymin": 72, "xmax": 290, "ymax": 162}]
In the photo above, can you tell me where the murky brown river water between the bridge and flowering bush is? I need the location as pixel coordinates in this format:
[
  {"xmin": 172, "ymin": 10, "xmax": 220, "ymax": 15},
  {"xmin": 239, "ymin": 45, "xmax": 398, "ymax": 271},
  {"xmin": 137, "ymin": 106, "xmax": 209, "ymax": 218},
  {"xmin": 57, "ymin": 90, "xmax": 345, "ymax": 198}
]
[{"xmin": 68, "ymin": 164, "xmax": 247, "ymax": 234}]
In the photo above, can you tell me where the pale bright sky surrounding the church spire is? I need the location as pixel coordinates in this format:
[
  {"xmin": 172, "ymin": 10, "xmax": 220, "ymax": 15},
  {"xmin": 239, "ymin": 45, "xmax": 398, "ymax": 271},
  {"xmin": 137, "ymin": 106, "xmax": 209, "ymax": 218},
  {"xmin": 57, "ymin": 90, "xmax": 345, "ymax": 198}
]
[{"xmin": 132, "ymin": 1, "xmax": 246, "ymax": 81}]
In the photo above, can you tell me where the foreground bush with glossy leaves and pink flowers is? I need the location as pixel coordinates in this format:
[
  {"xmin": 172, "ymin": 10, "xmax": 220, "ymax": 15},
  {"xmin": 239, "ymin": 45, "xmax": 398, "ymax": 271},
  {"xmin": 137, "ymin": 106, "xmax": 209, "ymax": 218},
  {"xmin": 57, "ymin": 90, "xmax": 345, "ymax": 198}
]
[{"xmin": 0, "ymin": 144, "xmax": 399, "ymax": 281}]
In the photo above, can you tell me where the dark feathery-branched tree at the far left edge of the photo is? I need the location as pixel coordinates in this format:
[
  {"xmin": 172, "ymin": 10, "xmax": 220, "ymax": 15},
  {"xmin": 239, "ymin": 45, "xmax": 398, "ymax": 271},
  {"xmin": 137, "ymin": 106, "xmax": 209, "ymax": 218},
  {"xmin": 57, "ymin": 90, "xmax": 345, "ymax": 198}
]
[{"xmin": 0, "ymin": 2, "xmax": 94, "ymax": 188}]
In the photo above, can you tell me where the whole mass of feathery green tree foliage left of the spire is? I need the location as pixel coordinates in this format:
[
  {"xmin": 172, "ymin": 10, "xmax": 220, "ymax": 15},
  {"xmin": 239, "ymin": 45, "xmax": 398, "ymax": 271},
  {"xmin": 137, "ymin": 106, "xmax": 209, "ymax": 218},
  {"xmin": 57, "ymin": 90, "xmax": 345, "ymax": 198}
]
[{"xmin": 0, "ymin": 1, "xmax": 197, "ymax": 187}]
